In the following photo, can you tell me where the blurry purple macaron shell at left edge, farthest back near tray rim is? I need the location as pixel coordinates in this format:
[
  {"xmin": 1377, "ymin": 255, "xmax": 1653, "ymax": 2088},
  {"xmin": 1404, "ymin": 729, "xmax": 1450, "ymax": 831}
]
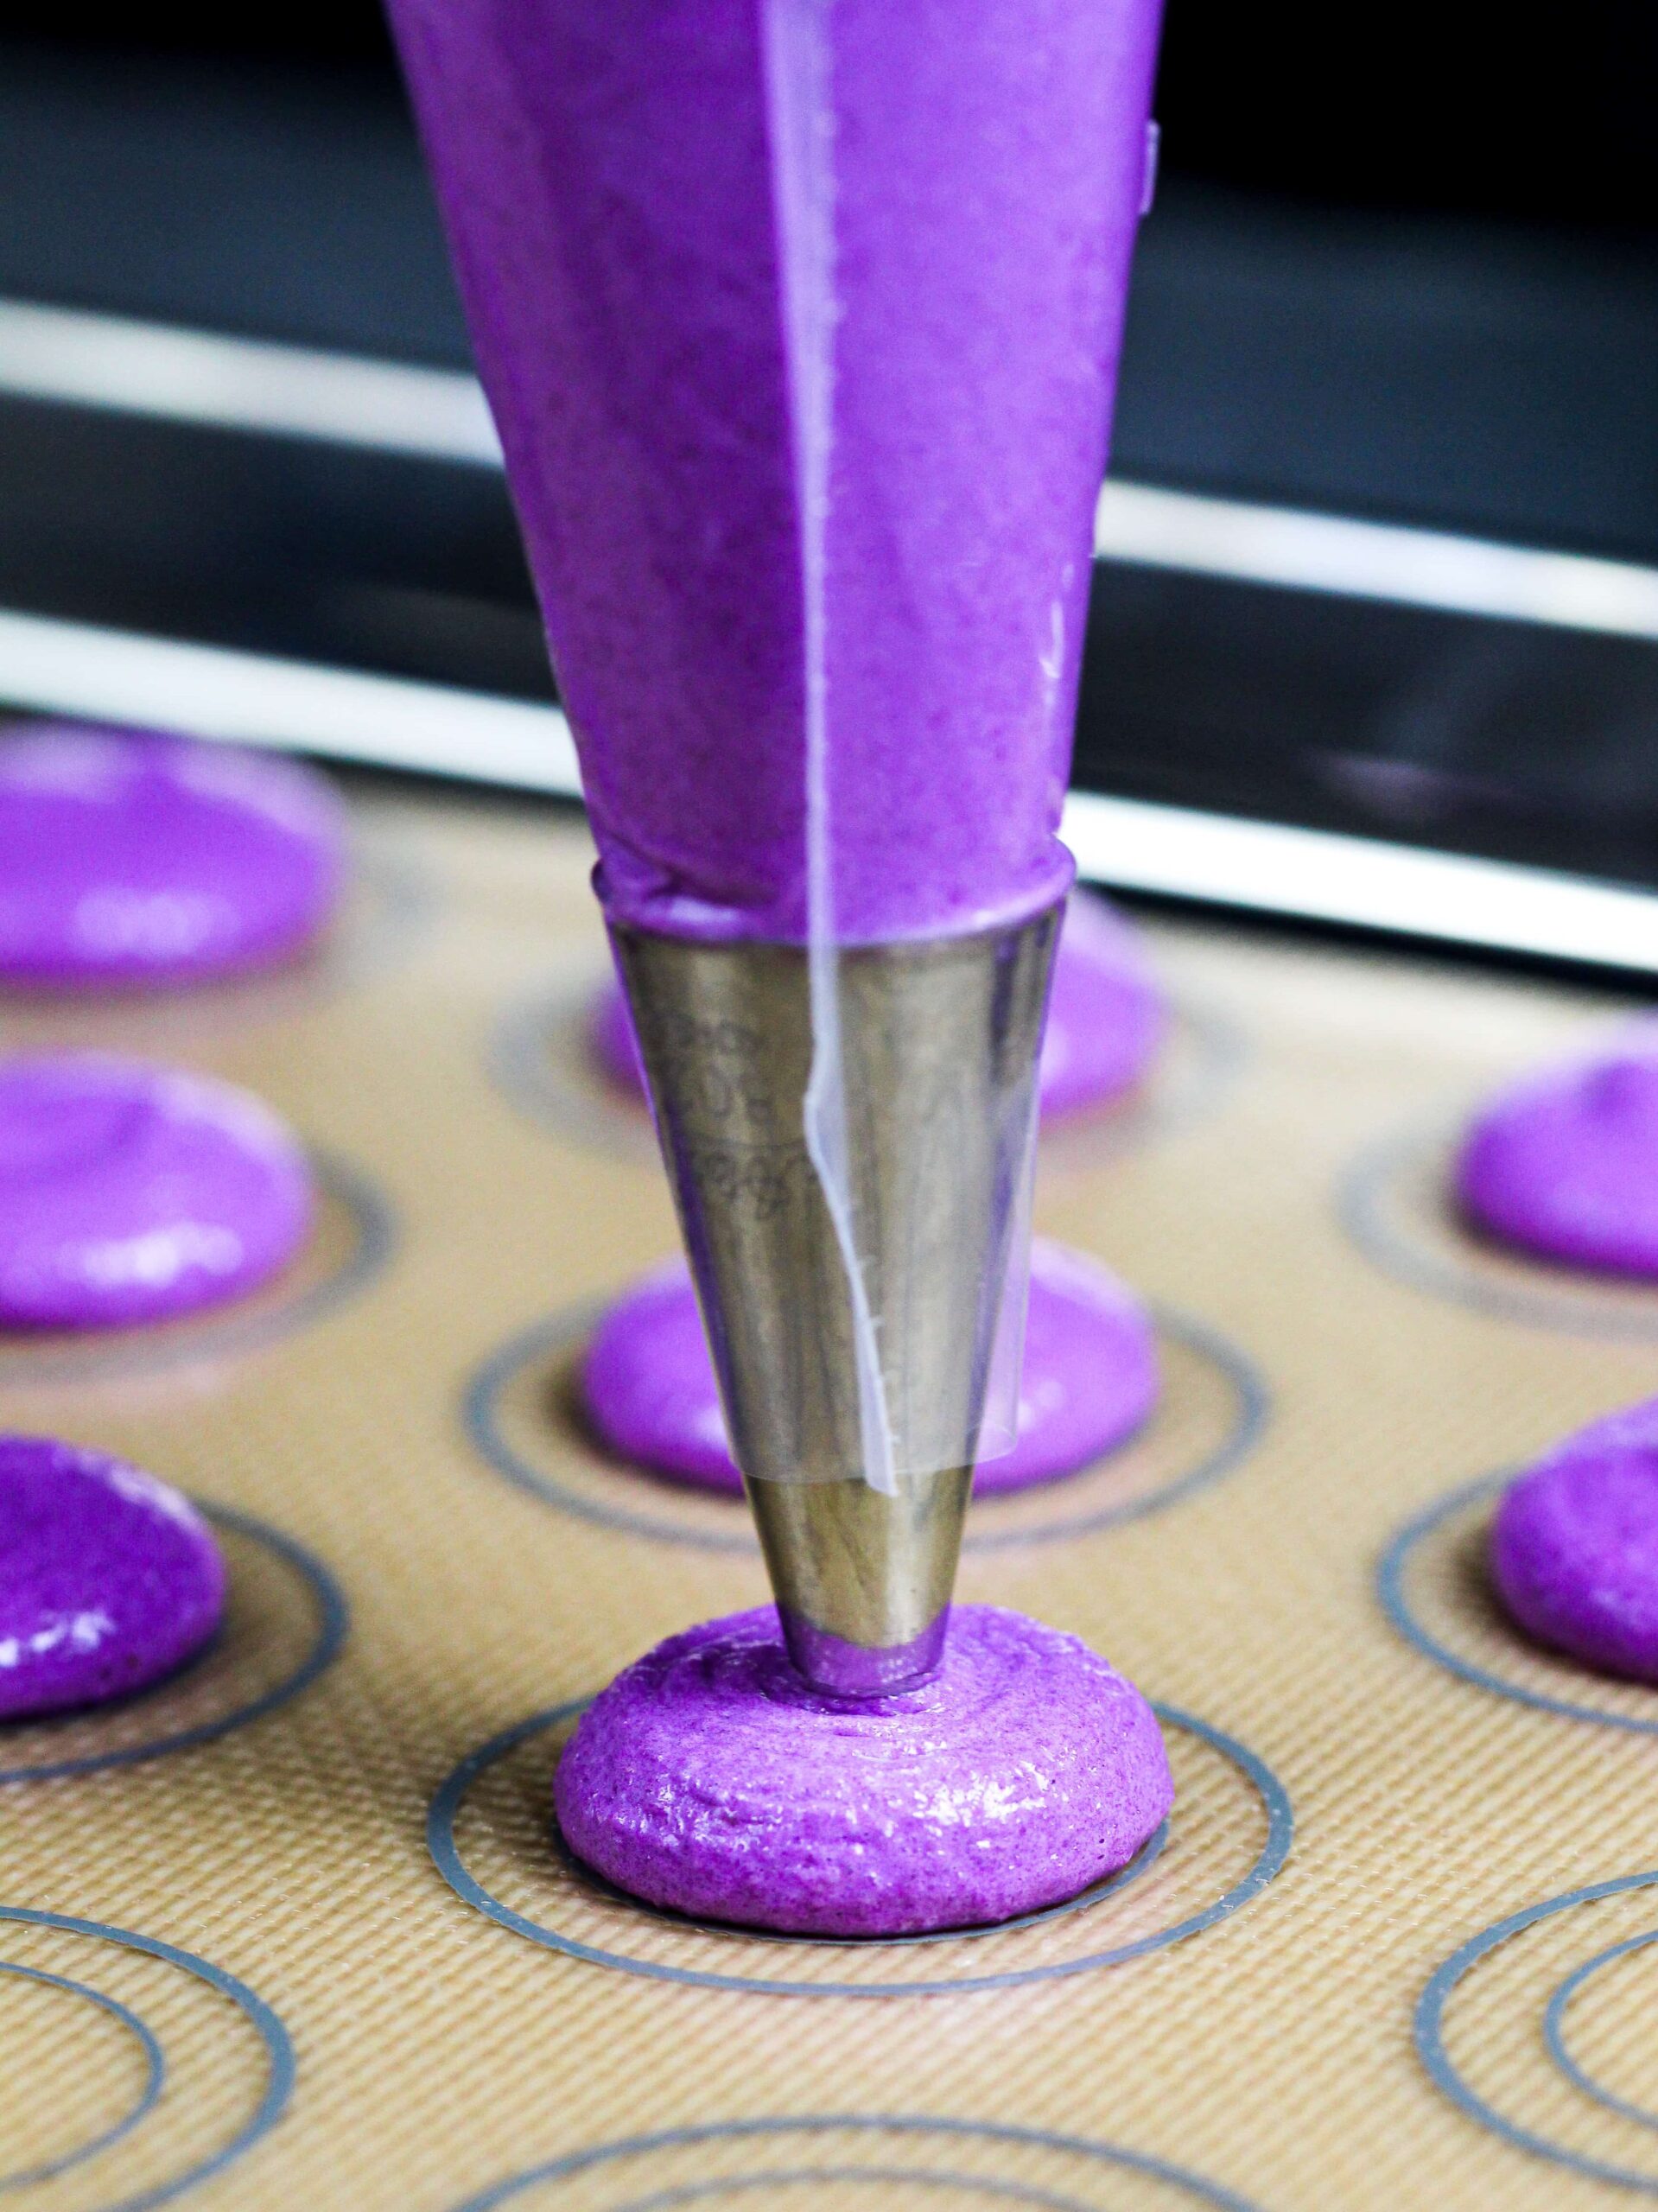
[{"xmin": 0, "ymin": 723, "xmax": 345, "ymax": 991}]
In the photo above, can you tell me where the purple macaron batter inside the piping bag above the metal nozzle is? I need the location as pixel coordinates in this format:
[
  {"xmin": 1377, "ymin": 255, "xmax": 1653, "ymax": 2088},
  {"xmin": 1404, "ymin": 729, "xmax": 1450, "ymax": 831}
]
[{"xmin": 391, "ymin": 0, "xmax": 1159, "ymax": 944}]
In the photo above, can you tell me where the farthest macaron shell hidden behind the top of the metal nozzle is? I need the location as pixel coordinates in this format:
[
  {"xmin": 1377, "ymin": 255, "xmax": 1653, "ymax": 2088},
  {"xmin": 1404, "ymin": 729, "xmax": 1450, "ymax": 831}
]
[{"xmin": 588, "ymin": 892, "xmax": 1167, "ymax": 1122}]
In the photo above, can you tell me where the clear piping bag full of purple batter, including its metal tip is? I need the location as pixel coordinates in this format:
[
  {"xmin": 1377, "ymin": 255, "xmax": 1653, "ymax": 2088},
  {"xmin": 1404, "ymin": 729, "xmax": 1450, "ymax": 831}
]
[{"xmin": 389, "ymin": 0, "xmax": 1159, "ymax": 1697}]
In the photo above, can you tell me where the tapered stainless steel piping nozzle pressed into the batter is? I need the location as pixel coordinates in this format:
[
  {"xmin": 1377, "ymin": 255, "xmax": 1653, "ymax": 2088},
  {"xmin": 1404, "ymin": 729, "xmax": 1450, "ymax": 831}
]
[{"xmin": 613, "ymin": 907, "xmax": 1059, "ymax": 1697}]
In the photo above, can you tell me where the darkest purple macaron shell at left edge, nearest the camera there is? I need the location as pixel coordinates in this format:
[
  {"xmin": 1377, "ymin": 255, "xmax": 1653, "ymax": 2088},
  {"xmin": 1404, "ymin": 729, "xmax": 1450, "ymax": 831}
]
[{"xmin": 0, "ymin": 1435, "xmax": 226, "ymax": 1721}]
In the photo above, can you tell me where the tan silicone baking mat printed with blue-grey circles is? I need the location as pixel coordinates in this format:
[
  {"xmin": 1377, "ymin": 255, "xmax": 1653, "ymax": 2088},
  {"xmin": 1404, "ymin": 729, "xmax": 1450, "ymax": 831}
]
[{"xmin": 0, "ymin": 787, "xmax": 1658, "ymax": 2212}]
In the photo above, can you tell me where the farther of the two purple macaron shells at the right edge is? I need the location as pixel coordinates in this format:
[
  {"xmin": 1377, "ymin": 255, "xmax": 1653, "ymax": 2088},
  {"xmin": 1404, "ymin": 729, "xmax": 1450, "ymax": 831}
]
[{"xmin": 1455, "ymin": 1022, "xmax": 1658, "ymax": 1276}]
